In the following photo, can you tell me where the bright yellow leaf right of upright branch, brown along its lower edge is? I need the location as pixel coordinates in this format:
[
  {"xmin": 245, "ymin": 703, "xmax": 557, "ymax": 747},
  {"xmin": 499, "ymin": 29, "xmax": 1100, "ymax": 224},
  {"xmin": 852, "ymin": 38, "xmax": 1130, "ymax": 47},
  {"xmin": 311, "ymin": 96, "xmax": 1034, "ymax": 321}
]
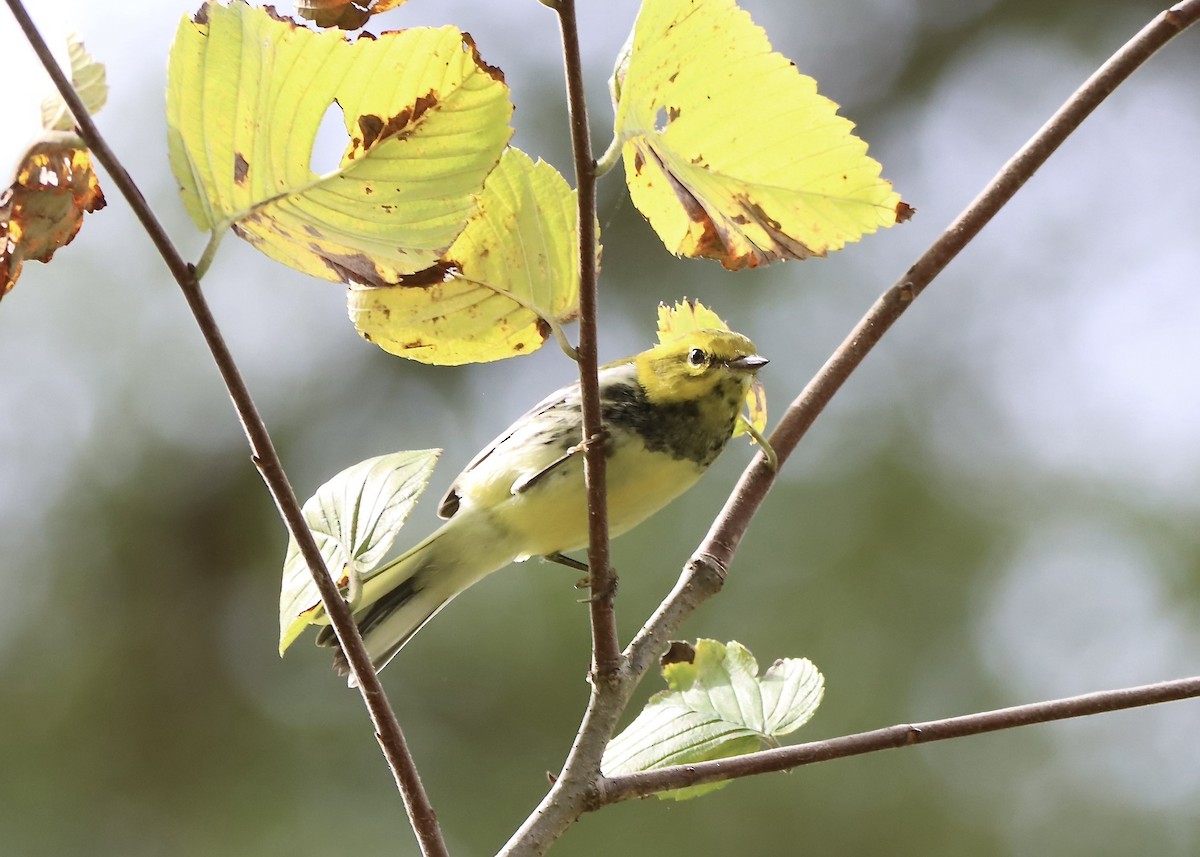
[{"xmin": 612, "ymin": 0, "xmax": 911, "ymax": 270}]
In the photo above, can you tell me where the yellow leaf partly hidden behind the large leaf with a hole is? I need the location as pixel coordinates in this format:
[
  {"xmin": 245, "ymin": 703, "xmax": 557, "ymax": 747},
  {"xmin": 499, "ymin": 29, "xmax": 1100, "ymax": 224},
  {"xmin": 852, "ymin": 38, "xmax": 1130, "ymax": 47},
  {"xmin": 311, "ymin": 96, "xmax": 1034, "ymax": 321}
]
[{"xmin": 348, "ymin": 148, "xmax": 580, "ymax": 366}]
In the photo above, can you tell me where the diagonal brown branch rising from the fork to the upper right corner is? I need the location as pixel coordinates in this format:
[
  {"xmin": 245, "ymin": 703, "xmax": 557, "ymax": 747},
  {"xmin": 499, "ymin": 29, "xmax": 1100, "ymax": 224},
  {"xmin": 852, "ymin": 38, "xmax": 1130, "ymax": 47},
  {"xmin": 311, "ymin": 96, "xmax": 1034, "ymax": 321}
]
[{"xmin": 626, "ymin": 0, "xmax": 1200, "ymax": 679}]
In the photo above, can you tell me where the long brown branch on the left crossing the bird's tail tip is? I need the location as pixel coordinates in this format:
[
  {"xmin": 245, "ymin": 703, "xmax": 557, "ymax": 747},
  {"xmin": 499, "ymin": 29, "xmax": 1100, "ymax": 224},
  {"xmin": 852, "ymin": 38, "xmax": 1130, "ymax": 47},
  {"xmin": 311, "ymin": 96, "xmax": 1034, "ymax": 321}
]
[{"xmin": 6, "ymin": 0, "xmax": 448, "ymax": 855}]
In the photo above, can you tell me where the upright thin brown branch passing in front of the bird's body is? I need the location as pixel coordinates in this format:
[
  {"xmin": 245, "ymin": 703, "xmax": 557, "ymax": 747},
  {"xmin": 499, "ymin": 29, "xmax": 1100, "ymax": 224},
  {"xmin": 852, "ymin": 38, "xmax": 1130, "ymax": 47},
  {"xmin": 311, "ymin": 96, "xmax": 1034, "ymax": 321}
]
[{"xmin": 554, "ymin": 0, "xmax": 620, "ymax": 681}]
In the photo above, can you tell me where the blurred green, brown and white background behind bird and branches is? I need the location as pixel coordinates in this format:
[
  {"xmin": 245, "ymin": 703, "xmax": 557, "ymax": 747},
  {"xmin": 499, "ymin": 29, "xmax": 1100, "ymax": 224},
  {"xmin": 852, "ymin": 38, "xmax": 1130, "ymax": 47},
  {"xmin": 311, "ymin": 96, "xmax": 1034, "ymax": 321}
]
[{"xmin": 0, "ymin": 0, "xmax": 1200, "ymax": 857}]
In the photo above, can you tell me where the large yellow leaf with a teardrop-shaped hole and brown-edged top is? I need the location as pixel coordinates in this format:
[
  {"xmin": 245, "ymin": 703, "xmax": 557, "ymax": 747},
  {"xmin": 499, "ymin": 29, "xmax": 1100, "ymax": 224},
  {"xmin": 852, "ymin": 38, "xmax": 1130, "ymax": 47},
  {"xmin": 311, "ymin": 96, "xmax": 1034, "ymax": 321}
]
[{"xmin": 167, "ymin": 4, "xmax": 512, "ymax": 284}]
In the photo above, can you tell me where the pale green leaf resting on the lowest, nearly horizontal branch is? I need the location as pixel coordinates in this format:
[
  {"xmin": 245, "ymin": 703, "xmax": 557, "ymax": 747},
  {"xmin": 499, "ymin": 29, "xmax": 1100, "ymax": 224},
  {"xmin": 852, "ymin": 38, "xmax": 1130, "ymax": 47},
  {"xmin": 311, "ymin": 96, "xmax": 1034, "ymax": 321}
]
[{"xmin": 600, "ymin": 640, "xmax": 824, "ymax": 801}]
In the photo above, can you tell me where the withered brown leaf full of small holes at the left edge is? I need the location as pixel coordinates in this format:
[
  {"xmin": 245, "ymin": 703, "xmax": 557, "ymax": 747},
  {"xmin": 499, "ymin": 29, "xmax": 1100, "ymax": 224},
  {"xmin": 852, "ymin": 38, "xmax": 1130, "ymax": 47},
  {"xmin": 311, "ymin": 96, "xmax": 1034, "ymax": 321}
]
[{"xmin": 0, "ymin": 138, "xmax": 104, "ymax": 298}]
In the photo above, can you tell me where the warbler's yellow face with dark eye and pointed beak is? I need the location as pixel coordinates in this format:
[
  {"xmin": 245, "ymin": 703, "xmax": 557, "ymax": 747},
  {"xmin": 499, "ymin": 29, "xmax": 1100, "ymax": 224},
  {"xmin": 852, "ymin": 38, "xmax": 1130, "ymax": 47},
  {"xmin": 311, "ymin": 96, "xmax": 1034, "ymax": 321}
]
[{"xmin": 635, "ymin": 330, "xmax": 767, "ymax": 403}]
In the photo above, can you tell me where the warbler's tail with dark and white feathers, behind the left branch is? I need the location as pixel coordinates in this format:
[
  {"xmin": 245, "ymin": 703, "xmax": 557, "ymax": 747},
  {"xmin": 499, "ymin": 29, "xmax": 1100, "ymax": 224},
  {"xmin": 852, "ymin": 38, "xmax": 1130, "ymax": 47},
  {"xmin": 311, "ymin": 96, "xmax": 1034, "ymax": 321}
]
[{"xmin": 317, "ymin": 506, "xmax": 512, "ymax": 687}]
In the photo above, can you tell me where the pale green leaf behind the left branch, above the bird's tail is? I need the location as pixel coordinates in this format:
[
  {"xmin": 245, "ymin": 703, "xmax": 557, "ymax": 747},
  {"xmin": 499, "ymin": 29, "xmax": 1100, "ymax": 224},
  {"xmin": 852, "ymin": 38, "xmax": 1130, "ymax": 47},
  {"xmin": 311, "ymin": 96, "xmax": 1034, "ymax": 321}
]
[{"xmin": 280, "ymin": 449, "xmax": 442, "ymax": 654}]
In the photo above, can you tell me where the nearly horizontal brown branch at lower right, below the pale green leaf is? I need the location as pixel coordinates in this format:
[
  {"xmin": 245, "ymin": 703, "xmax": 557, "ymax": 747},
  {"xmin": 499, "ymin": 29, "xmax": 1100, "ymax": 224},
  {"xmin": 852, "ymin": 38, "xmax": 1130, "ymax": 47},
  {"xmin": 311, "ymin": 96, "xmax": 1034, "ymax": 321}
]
[{"xmin": 600, "ymin": 676, "xmax": 1200, "ymax": 809}]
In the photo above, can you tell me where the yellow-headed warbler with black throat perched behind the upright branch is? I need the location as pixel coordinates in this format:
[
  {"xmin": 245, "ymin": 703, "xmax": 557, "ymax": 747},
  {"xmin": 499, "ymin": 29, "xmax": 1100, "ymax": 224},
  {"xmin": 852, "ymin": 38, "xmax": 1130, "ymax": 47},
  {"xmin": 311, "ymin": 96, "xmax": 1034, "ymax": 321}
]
[{"xmin": 316, "ymin": 329, "xmax": 767, "ymax": 675}]
